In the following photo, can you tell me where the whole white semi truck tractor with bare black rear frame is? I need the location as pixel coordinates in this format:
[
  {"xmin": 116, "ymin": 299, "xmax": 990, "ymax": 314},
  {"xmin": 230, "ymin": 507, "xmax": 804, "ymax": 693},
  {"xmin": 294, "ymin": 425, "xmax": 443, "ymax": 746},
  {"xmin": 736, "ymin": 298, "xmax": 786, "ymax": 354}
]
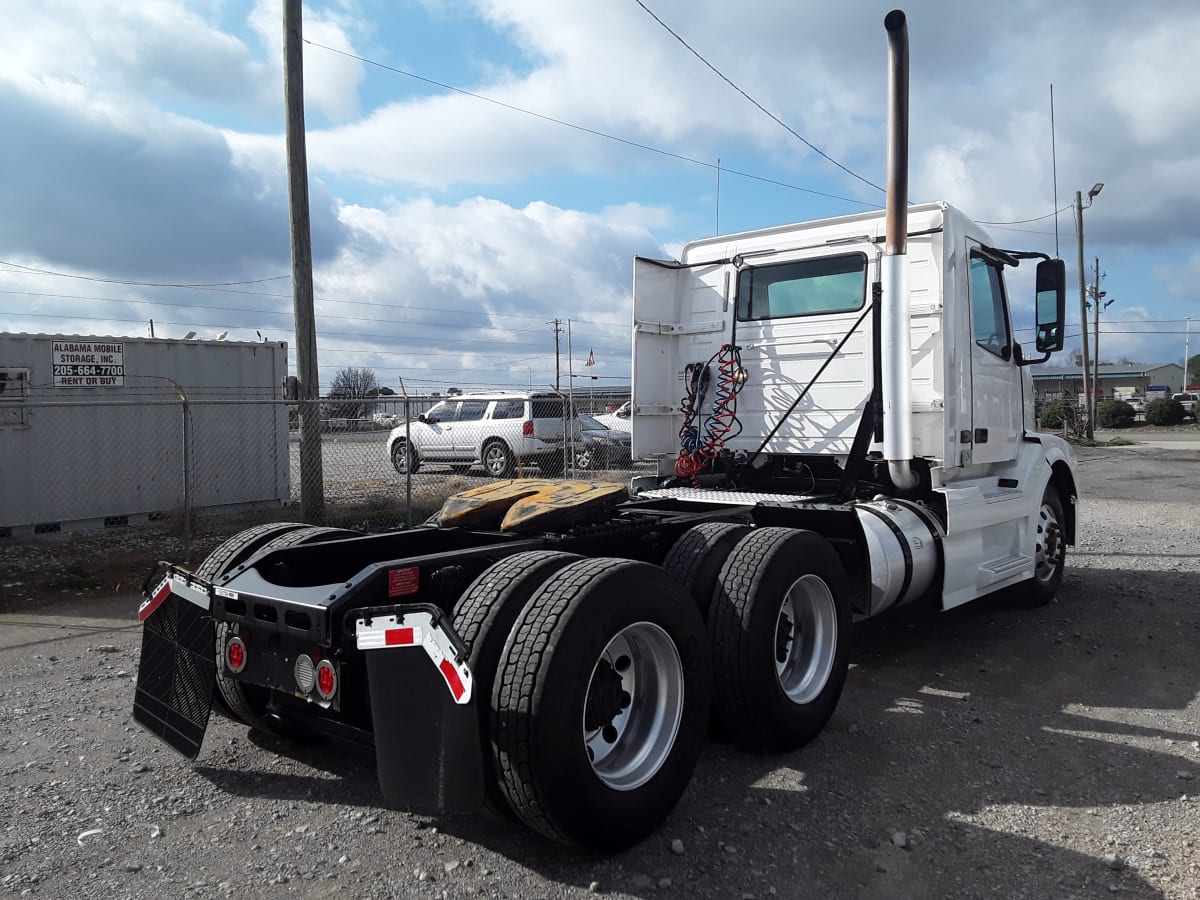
[{"xmin": 134, "ymin": 11, "xmax": 1078, "ymax": 850}]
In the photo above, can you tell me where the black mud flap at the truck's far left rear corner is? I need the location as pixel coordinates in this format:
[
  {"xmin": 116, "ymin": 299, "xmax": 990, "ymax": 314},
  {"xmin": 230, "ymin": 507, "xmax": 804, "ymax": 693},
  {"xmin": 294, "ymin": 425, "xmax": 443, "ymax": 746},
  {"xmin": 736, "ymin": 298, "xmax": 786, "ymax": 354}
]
[{"xmin": 133, "ymin": 594, "xmax": 216, "ymax": 760}]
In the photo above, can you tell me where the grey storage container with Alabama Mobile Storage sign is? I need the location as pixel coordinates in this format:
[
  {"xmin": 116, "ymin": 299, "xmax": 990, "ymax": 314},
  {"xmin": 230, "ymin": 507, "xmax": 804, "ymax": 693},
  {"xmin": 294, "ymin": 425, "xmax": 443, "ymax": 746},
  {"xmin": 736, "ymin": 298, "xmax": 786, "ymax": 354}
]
[{"xmin": 0, "ymin": 334, "xmax": 290, "ymax": 536}]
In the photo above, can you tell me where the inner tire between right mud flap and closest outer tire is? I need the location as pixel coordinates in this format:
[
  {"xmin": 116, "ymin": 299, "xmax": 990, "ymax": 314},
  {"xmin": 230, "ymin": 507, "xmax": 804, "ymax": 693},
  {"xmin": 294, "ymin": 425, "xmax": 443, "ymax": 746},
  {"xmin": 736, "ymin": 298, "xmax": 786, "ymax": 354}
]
[{"xmin": 452, "ymin": 550, "xmax": 582, "ymax": 815}]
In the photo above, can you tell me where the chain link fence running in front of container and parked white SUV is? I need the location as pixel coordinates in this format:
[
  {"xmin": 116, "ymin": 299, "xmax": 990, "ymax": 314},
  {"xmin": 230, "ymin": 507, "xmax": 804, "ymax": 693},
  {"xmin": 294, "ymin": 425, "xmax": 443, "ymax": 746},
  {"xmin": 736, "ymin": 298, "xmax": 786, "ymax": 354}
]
[{"xmin": 0, "ymin": 391, "xmax": 635, "ymax": 548}]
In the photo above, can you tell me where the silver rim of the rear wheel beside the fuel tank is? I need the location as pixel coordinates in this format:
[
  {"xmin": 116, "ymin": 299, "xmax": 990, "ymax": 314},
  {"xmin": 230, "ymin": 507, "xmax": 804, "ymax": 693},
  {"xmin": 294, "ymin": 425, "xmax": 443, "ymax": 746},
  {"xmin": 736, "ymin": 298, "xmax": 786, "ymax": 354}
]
[{"xmin": 775, "ymin": 575, "xmax": 838, "ymax": 703}]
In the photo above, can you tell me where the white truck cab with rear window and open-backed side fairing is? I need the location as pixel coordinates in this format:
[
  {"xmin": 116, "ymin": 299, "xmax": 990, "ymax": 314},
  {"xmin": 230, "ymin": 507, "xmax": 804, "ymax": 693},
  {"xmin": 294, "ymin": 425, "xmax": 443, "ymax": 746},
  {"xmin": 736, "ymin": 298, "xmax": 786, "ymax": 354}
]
[{"xmin": 632, "ymin": 203, "xmax": 1075, "ymax": 607}]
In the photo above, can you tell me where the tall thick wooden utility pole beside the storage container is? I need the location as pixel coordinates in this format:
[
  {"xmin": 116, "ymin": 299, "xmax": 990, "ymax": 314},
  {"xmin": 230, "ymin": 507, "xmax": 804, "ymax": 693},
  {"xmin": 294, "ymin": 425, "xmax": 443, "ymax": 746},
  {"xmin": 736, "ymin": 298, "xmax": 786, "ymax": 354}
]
[{"xmin": 283, "ymin": 0, "xmax": 325, "ymax": 522}]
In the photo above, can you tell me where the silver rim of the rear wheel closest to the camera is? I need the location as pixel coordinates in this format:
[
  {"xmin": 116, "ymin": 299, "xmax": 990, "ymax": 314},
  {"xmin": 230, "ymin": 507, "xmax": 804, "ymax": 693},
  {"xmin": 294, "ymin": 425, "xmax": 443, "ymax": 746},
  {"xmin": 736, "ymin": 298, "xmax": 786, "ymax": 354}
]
[{"xmin": 583, "ymin": 622, "xmax": 684, "ymax": 791}]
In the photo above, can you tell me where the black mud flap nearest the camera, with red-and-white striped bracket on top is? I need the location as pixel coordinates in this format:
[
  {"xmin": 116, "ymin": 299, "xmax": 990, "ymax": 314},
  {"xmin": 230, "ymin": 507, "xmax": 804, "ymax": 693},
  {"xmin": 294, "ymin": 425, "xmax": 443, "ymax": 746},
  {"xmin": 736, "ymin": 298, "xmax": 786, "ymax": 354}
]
[{"xmin": 359, "ymin": 605, "xmax": 487, "ymax": 812}]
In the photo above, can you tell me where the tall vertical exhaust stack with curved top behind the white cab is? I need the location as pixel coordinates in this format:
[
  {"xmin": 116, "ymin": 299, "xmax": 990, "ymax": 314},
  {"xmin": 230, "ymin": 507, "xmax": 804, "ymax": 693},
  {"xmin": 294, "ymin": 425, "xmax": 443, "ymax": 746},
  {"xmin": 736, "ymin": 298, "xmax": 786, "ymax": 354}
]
[{"xmin": 880, "ymin": 10, "xmax": 917, "ymax": 491}]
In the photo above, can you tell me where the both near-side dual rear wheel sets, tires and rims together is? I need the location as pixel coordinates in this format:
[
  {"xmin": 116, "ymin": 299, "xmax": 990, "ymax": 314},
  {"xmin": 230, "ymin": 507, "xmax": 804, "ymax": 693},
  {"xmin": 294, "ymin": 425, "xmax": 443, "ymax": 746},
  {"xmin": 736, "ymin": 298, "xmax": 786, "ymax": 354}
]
[{"xmin": 454, "ymin": 523, "xmax": 850, "ymax": 851}]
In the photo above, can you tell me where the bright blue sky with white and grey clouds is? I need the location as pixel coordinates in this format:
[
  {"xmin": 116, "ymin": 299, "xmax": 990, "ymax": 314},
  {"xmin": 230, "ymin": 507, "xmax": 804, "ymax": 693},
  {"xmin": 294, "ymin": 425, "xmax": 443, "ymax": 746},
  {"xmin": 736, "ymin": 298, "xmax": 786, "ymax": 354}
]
[{"xmin": 0, "ymin": 0, "xmax": 1200, "ymax": 389}]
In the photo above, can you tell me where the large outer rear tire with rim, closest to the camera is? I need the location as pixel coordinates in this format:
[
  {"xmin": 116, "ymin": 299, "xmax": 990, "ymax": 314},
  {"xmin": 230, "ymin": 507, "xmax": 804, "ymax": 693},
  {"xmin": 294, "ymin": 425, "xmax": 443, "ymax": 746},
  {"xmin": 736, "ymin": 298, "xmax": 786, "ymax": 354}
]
[{"xmin": 491, "ymin": 558, "xmax": 712, "ymax": 851}]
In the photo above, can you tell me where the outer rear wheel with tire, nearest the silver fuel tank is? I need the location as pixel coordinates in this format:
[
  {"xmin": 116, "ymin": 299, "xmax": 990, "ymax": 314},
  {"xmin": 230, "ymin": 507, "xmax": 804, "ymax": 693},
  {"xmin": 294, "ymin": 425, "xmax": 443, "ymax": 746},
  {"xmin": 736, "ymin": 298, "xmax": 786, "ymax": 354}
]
[{"xmin": 708, "ymin": 528, "xmax": 851, "ymax": 750}]
